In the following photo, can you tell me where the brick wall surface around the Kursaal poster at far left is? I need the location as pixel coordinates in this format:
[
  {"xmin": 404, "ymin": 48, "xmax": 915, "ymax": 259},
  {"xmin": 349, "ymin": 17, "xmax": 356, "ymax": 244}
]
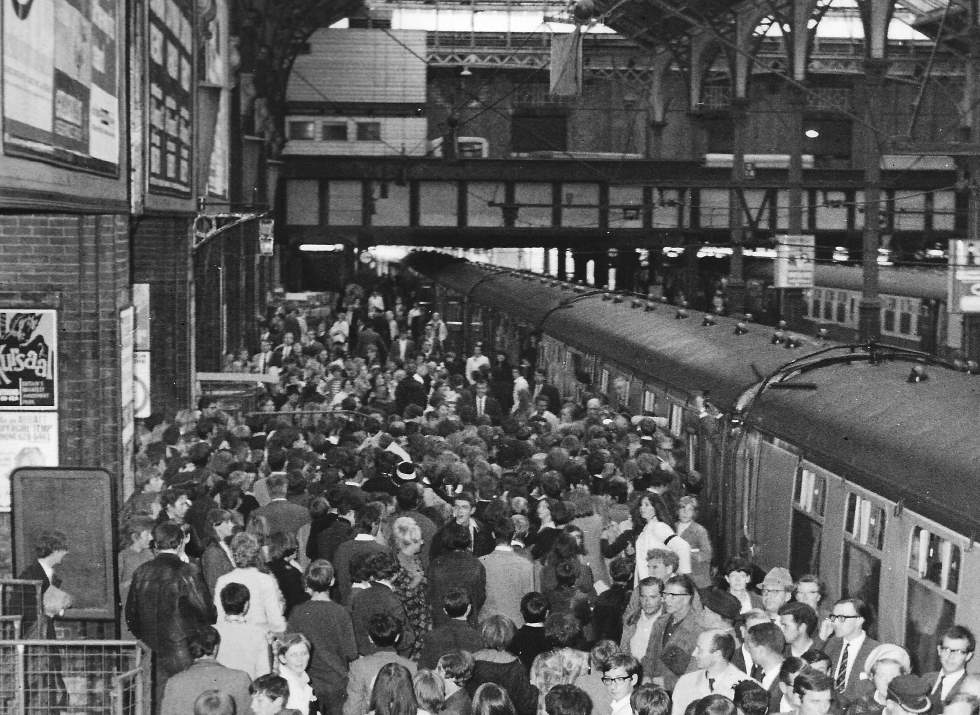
[{"xmin": 0, "ymin": 214, "xmax": 131, "ymax": 574}]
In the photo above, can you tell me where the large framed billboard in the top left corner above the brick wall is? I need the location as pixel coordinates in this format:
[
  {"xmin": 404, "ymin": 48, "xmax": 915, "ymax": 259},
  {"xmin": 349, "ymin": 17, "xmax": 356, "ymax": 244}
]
[{"xmin": 0, "ymin": 0, "xmax": 121, "ymax": 176}]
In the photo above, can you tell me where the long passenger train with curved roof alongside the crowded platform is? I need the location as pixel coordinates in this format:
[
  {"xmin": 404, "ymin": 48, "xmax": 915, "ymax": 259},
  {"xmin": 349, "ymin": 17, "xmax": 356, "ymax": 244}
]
[{"xmin": 409, "ymin": 254, "xmax": 980, "ymax": 670}]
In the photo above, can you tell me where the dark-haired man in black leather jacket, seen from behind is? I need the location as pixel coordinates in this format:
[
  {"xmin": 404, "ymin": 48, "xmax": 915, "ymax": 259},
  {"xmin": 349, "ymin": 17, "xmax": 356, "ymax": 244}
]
[{"xmin": 126, "ymin": 521, "xmax": 215, "ymax": 702}]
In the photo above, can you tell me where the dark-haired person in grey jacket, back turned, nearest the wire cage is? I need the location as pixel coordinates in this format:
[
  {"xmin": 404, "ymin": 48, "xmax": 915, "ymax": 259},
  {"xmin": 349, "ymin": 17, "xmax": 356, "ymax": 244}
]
[{"xmin": 160, "ymin": 626, "xmax": 251, "ymax": 715}]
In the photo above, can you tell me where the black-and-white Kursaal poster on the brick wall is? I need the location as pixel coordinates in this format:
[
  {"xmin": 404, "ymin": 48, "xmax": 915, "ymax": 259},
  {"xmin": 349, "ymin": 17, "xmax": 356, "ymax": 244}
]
[{"xmin": 0, "ymin": 308, "xmax": 58, "ymax": 411}]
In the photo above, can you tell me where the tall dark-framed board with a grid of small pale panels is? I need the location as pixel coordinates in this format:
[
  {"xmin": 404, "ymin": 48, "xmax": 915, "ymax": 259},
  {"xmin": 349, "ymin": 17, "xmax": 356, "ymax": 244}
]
[{"xmin": 147, "ymin": 0, "xmax": 194, "ymax": 196}]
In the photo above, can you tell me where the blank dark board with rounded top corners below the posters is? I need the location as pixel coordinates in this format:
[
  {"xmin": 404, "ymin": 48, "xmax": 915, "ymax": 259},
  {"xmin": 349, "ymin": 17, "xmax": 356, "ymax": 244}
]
[{"xmin": 12, "ymin": 467, "xmax": 116, "ymax": 620}]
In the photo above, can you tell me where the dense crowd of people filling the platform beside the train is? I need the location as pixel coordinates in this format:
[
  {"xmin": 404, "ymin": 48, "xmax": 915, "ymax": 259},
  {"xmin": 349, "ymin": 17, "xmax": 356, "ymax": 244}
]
[{"xmin": 107, "ymin": 276, "xmax": 980, "ymax": 715}]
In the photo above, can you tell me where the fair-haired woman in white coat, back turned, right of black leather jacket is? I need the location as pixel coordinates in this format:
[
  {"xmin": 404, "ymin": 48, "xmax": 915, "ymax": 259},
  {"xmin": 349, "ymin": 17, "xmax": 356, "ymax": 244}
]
[{"xmin": 214, "ymin": 531, "xmax": 286, "ymax": 633}]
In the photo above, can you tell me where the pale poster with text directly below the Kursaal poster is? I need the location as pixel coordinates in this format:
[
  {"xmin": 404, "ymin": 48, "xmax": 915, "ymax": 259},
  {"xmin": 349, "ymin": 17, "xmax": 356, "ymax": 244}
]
[{"xmin": 0, "ymin": 412, "xmax": 58, "ymax": 512}]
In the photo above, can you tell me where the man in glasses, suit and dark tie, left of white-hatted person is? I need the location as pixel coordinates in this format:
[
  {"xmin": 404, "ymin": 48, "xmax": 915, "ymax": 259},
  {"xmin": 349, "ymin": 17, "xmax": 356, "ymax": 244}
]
[{"xmin": 824, "ymin": 598, "xmax": 878, "ymax": 706}]
